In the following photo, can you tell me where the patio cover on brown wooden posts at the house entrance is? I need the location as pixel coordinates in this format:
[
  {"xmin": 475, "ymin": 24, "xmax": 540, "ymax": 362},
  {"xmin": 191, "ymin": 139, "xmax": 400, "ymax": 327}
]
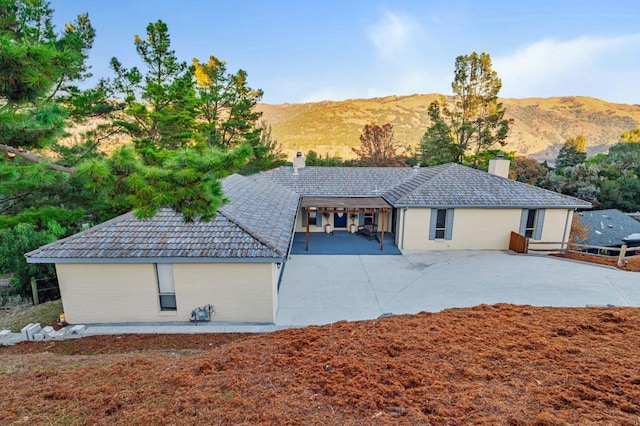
[{"xmin": 302, "ymin": 197, "xmax": 397, "ymax": 252}]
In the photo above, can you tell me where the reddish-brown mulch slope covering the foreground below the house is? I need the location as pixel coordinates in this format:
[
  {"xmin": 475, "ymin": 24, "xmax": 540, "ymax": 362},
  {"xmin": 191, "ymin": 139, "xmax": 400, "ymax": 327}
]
[{"xmin": 0, "ymin": 304, "xmax": 640, "ymax": 425}]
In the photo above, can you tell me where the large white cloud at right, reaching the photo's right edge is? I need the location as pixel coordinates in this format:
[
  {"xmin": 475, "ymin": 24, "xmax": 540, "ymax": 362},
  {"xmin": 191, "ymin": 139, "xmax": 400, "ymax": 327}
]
[{"xmin": 494, "ymin": 34, "xmax": 640, "ymax": 101}]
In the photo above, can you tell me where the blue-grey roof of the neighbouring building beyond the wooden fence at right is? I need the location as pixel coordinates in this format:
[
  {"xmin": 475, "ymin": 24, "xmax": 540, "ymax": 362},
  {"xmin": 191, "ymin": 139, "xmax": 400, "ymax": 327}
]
[{"xmin": 577, "ymin": 209, "xmax": 640, "ymax": 247}]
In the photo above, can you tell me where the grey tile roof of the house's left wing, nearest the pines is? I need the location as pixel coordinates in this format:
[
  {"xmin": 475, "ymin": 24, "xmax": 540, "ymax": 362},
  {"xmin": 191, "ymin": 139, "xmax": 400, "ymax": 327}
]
[{"xmin": 26, "ymin": 175, "xmax": 298, "ymax": 263}]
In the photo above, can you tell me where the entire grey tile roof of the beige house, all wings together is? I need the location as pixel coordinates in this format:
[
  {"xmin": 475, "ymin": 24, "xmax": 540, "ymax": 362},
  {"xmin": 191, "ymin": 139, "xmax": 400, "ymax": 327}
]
[{"xmin": 25, "ymin": 164, "xmax": 591, "ymax": 263}]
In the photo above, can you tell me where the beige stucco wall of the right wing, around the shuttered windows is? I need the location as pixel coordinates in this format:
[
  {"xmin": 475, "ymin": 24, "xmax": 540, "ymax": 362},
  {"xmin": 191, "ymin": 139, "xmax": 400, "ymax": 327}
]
[{"xmin": 396, "ymin": 208, "xmax": 570, "ymax": 250}]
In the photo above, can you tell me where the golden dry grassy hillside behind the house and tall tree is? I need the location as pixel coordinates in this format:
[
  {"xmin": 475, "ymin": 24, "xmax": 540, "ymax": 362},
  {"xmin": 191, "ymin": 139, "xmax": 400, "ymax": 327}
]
[{"xmin": 258, "ymin": 94, "xmax": 640, "ymax": 159}]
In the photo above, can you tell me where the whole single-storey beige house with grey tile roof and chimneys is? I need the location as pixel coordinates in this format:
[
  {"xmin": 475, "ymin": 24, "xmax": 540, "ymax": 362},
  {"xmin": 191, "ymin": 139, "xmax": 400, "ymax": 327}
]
[{"xmin": 25, "ymin": 156, "xmax": 591, "ymax": 323}]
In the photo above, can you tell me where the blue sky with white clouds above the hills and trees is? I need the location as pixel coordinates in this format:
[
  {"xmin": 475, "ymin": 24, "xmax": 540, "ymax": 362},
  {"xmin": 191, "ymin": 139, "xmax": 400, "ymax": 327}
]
[{"xmin": 51, "ymin": 0, "xmax": 640, "ymax": 104}]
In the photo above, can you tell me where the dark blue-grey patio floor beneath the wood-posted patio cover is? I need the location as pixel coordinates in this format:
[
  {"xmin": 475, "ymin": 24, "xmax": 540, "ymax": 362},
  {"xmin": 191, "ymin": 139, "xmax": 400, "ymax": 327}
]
[{"xmin": 291, "ymin": 231, "xmax": 402, "ymax": 256}]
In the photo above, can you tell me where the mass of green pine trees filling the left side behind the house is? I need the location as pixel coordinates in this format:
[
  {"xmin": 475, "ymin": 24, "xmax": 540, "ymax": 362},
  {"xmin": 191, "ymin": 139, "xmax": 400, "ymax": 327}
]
[{"xmin": 0, "ymin": 0, "xmax": 268, "ymax": 300}]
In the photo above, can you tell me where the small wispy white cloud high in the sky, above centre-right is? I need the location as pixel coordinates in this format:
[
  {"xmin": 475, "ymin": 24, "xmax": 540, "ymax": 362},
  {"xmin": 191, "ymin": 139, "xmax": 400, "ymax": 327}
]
[{"xmin": 368, "ymin": 10, "xmax": 420, "ymax": 60}]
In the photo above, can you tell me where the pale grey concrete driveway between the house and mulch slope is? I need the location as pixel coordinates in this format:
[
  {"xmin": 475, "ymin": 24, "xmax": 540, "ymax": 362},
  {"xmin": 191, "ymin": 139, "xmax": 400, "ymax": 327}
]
[{"xmin": 276, "ymin": 251, "xmax": 640, "ymax": 326}]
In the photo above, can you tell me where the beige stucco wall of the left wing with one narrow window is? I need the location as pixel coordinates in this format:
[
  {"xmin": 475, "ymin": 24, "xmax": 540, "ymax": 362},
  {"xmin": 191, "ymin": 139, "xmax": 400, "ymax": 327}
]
[{"xmin": 56, "ymin": 263, "xmax": 279, "ymax": 324}]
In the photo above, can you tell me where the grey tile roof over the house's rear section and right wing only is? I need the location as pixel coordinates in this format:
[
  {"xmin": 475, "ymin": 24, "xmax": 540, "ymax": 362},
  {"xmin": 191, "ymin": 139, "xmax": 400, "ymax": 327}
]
[{"xmin": 256, "ymin": 163, "xmax": 591, "ymax": 208}]
